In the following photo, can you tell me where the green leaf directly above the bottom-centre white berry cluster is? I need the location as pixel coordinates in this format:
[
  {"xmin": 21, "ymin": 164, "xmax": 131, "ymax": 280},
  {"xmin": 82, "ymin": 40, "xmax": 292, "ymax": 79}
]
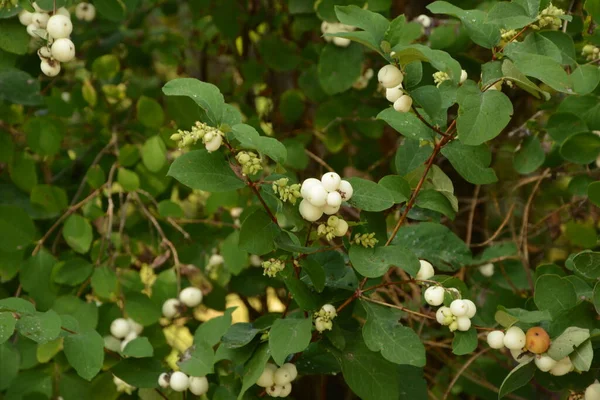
[{"xmin": 269, "ymin": 318, "xmax": 312, "ymax": 365}]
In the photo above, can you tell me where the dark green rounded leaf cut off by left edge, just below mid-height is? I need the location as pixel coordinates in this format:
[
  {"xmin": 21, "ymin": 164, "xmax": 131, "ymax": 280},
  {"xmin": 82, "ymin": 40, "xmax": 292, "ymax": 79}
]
[{"xmin": 0, "ymin": 205, "xmax": 35, "ymax": 253}]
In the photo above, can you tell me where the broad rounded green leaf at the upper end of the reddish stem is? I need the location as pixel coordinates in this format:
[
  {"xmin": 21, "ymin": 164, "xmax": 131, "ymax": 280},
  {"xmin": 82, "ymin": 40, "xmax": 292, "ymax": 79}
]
[{"xmin": 456, "ymin": 84, "xmax": 513, "ymax": 146}]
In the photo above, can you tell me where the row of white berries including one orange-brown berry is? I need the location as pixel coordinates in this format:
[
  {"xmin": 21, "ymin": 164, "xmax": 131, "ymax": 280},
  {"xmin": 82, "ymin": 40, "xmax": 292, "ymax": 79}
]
[{"xmin": 487, "ymin": 326, "xmax": 575, "ymax": 376}]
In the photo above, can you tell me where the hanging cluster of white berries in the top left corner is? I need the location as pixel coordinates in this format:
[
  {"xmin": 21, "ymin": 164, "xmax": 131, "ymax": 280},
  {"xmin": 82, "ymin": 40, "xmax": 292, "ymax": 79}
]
[{"xmin": 19, "ymin": 3, "xmax": 80, "ymax": 76}]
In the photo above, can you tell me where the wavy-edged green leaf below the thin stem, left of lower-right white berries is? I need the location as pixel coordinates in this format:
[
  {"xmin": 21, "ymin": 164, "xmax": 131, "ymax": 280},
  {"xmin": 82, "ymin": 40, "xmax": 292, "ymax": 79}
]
[{"xmin": 361, "ymin": 300, "xmax": 425, "ymax": 367}]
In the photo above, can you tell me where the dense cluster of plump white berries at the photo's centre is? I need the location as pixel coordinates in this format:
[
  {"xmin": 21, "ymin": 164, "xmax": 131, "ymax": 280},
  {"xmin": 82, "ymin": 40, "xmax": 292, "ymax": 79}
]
[{"xmin": 299, "ymin": 172, "xmax": 354, "ymax": 222}]
